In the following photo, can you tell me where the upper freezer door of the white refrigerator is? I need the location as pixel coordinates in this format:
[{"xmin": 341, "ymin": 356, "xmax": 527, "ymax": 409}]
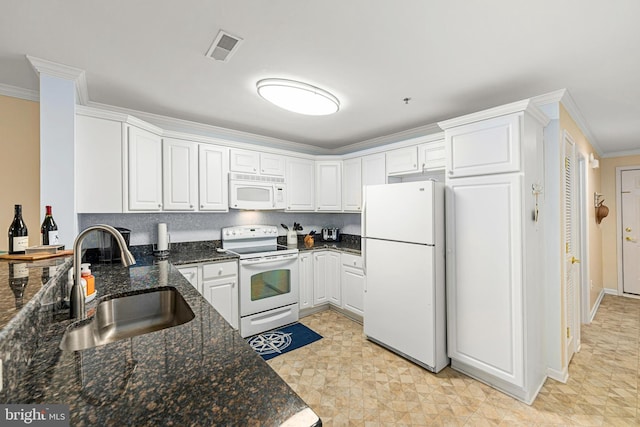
[{"xmin": 362, "ymin": 181, "xmax": 435, "ymax": 245}]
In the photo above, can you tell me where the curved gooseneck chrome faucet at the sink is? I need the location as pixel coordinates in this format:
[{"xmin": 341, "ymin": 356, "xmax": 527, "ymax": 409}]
[{"xmin": 69, "ymin": 224, "xmax": 136, "ymax": 319}]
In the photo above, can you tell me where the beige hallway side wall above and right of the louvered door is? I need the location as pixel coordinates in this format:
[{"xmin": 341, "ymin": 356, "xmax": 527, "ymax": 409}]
[{"xmin": 560, "ymin": 104, "xmax": 611, "ymax": 310}]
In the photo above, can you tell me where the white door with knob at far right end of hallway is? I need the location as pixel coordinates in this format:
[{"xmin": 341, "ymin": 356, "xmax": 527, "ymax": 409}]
[{"xmin": 620, "ymin": 169, "xmax": 640, "ymax": 295}]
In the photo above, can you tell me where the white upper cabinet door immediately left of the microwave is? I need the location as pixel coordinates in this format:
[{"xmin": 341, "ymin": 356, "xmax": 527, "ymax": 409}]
[{"xmin": 198, "ymin": 144, "xmax": 229, "ymax": 212}]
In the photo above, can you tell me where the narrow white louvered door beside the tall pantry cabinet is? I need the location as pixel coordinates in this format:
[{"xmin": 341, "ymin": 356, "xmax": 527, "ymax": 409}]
[{"xmin": 563, "ymin": 132, "xmax": 580, "ymax": 364}]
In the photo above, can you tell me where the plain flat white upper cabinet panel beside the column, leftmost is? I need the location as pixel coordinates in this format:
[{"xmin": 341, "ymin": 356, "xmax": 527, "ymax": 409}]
[{"xmin": 75, "ymin": 115, "xmax": 123, "ymax": 213}]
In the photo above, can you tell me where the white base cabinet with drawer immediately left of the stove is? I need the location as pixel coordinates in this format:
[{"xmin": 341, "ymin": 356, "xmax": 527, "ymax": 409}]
[{"xmin": 202, "ymin": 262, "xmax": 238, "ymax": 329}]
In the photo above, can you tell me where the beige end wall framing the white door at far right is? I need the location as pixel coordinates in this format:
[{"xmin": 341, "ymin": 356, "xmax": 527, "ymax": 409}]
[{"xmin": 600, "ymin": 155, "xmax": 640, "ymax": 290}]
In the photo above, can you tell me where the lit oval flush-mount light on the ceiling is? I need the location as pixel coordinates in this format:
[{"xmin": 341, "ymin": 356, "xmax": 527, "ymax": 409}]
[{"xmin": 256, "ymin": 79, "xmax": 340, "ymax": 116}]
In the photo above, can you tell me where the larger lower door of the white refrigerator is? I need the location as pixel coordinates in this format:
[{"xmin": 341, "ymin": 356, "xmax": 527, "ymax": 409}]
[{"xmin": 364, "ymin": 239, "xmax": 436, "ymax": 368}]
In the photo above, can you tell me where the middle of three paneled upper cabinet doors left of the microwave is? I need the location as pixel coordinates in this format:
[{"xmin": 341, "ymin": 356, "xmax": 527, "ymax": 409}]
[{"xmin": 162, "ymin": 138, "xmax": 198, "ymax": 211}]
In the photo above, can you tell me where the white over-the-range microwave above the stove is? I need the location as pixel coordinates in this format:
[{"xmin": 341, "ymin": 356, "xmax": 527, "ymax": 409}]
[{"xmin": 229, "ymin": 173, "xmax": 287, "ymax": 210}]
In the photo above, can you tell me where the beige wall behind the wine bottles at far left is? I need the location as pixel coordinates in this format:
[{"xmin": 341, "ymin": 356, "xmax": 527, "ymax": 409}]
[{"xmin": 0, "ymin": 95, "xmax": 40, "ymax": 251}]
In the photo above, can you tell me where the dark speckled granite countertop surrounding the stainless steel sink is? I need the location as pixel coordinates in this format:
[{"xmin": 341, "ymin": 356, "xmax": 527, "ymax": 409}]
[{"xmin": 0, "ymin": 261, "xmax": 320, "ymax": 426}]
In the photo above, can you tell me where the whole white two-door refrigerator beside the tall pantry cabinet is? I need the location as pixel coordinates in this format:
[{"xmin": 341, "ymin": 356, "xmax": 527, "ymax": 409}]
[{"xmin": 362, "ymin": 181, "xmax": 449, "ymax": 372}]
